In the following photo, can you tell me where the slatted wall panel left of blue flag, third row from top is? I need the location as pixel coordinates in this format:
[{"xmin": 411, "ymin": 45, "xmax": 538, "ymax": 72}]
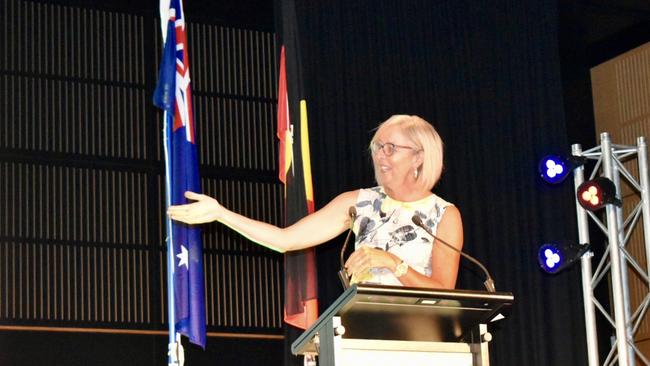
[{"xmin": 0, "ymin": 162, "xmax": 149, "ymax": 247}]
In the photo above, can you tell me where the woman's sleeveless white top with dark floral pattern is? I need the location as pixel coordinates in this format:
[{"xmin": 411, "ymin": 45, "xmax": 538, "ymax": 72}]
[{"xmin": 354, "ymin": 187, "xmax": 452, "ymax": 286}]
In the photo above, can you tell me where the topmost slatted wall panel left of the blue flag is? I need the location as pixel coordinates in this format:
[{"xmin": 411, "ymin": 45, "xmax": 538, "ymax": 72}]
[{"xmin": 2, "ymin": 0, "xmax": 145, "ymax": 85}]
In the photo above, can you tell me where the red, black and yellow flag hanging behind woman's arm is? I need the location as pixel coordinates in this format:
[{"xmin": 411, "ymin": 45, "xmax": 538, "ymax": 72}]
[{"xmin": 277, "ymin": 0, "xmax": 318, "ymax": 329}]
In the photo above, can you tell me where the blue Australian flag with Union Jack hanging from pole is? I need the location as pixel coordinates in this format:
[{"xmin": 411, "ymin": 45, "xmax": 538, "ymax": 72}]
[{"xmin": 154, "ymin": 0, "xmax": 206, "ymax": 348}]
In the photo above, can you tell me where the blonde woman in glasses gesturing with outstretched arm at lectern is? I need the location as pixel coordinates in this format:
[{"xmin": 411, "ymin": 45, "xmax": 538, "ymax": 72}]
[{"xmin": 167, "ymin": 115, "xmax": 463, "ymax": 289}]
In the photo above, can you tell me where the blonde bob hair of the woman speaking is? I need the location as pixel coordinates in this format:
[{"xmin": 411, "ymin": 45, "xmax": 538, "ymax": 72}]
[{"xmin": 370, "ymin": 114, "xmax": 443, "ymax": 191}]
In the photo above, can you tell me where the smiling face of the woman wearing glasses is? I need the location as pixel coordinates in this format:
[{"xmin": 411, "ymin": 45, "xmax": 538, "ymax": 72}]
[{"xmin": 372, "ymin": 126, "xmax": 418, "ymax": 189}]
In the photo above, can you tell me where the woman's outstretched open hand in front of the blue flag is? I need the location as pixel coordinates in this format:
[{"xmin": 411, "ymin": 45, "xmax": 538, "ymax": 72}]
[{"xmin": 167, "ymin": 191, "xmax": 223, "ymax": 224}]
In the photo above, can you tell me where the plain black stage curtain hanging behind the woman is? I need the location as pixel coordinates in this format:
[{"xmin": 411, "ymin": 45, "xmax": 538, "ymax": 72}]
[{"xmin": 284, "ymin": 0, "xmax": 586, "ymax": 366}]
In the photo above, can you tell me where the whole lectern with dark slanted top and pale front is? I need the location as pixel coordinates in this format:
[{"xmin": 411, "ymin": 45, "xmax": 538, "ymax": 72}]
[{"xmin": 291, "ymin": 285, "xmax": 514, "ymax": 366}]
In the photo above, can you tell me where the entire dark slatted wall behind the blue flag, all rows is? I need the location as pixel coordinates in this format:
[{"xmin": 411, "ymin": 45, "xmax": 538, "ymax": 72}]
[{"xmin": 0, "ymin": 0, "xmax": 283, "ymax": 333}]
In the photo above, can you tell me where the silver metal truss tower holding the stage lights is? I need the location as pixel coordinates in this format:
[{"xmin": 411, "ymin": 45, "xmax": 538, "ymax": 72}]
[{"xmin": 571, "ymin": 133, "xmax": 650, "ymax": 366}]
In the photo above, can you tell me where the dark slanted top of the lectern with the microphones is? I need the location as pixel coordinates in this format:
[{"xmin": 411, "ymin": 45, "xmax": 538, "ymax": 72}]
[{"xmin": 292, "ymin": 285, "xmax": 514, "ymax": 354}]
